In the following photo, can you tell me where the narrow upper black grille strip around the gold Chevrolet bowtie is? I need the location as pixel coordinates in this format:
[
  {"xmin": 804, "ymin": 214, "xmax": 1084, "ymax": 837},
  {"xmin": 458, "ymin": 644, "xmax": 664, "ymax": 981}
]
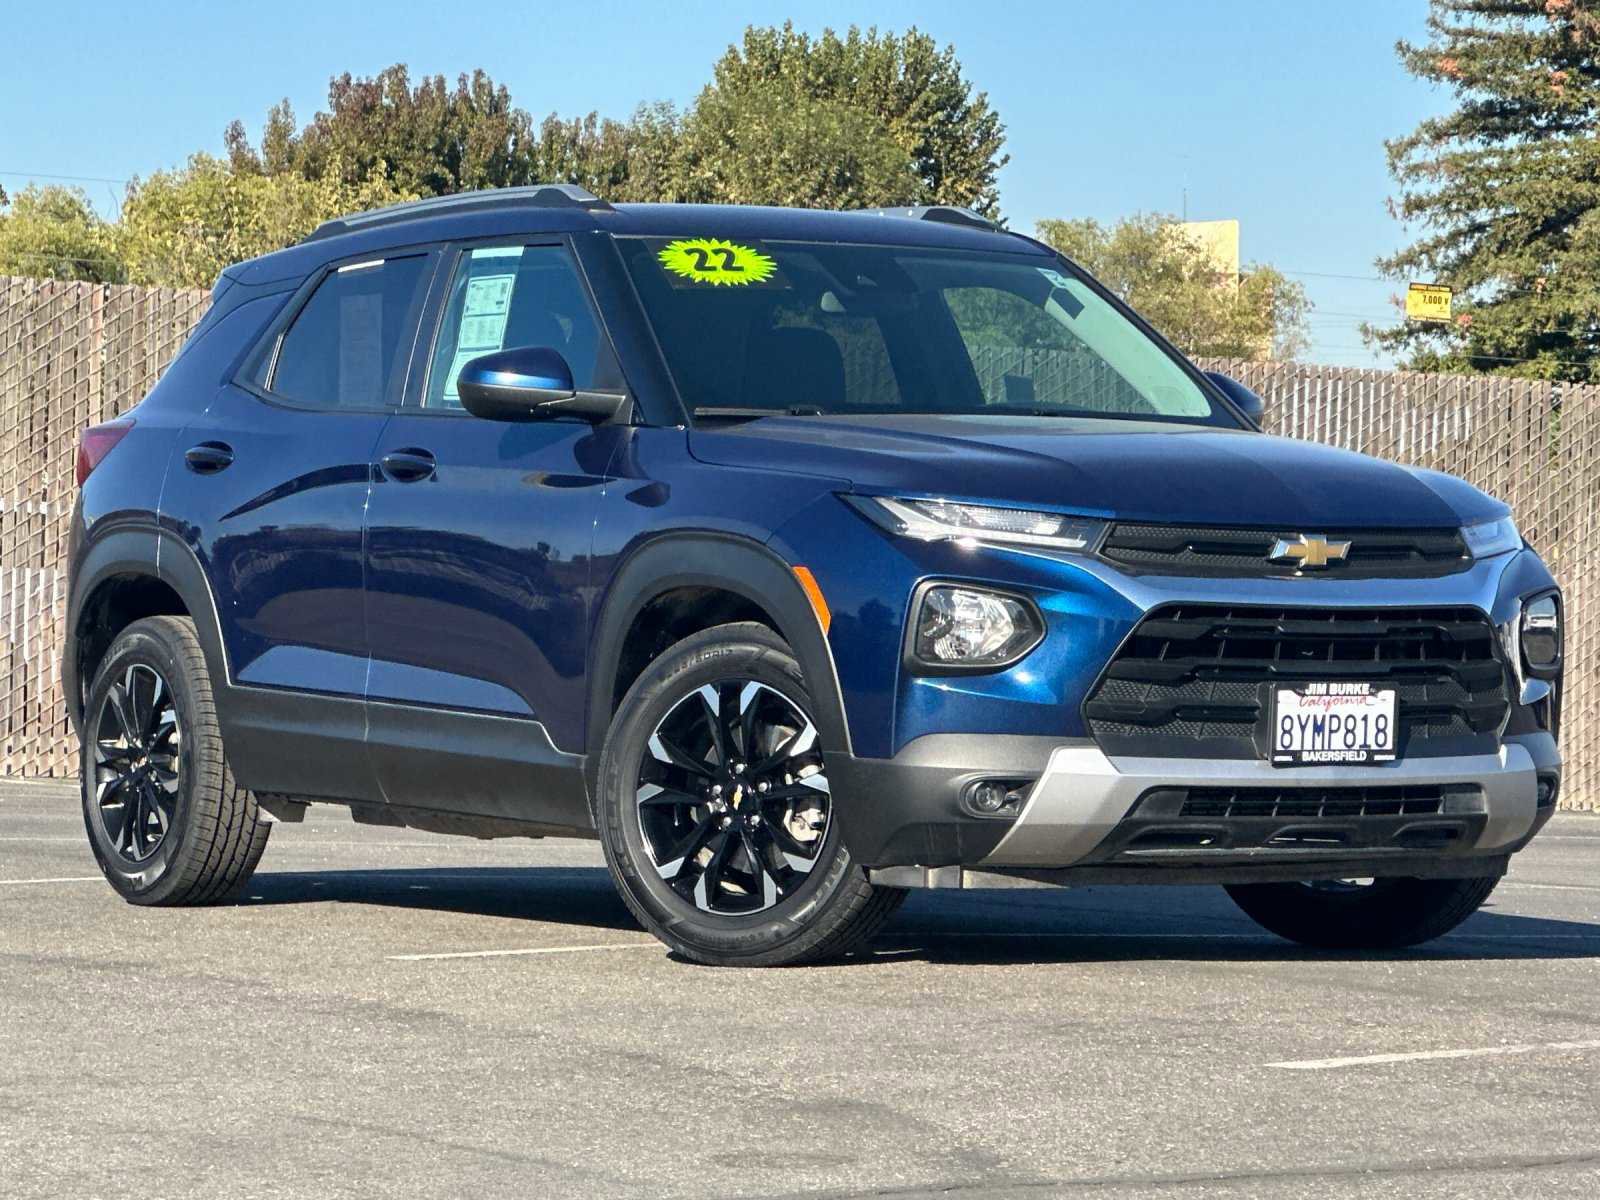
[{"xmin": 1099, "ymin": 522, "xmax": 1472, "ymax": 579}]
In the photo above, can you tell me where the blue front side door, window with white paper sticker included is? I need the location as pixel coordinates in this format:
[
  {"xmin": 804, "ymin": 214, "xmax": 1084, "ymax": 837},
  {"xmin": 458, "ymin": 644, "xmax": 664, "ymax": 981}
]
[{"xmin": 366, "ymin": 240, "xmax": 622, "ymax": 827}]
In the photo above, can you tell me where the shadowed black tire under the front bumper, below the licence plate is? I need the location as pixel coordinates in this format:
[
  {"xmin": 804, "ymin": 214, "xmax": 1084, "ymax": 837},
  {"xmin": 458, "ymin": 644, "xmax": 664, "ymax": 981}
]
[{"xmin": 1227, "ymin": 875, "xmax": 1499, "ymax": 950}]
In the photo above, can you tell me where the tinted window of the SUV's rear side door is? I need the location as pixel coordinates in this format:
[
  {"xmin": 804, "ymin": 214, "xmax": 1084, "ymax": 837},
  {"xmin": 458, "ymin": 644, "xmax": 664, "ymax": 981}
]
[{"xmin": 269, "ymin": 254, "xmax": 429, "ymax": 408}]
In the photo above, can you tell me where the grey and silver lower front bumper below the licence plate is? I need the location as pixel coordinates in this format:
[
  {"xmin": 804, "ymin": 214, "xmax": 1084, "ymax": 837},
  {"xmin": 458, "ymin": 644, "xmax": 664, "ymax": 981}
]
[{"xmin": 827, "ymin": 733, "xmax": 1562, "ymax": 885}]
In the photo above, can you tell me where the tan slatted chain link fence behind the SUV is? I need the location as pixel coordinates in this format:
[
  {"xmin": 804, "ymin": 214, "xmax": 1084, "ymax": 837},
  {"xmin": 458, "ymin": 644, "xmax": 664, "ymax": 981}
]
[{"xmin": 0, "ymin": 278, "xmax": 1600, "ymax": 810}]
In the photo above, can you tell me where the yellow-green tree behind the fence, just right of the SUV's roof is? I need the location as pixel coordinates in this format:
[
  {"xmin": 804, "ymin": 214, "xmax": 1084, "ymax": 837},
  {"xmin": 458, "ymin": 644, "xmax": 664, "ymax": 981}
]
[{"xmin": 1038, "ymin": 213, "xmax": 1309, "ymax": 358}]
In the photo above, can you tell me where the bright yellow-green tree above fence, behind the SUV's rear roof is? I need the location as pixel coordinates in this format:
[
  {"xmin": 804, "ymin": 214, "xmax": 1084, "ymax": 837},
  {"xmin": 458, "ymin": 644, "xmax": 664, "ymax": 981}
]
[{"xmin": 118, "ymin": 154, "xmax": 416, "ymax": 288}]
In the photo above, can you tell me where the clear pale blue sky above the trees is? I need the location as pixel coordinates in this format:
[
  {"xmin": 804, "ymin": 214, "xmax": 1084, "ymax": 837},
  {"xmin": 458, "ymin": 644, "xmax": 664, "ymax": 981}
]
[{"xmin": 0, "ymin": 0, "xmax": 1448, "ymax": 365}]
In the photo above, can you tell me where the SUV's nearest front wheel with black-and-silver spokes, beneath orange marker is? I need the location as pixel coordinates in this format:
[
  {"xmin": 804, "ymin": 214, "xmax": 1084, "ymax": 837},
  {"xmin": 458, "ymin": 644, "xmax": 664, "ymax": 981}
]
[{"xmin": 597, "ymin": 624, "xmax": 906, "ymax": 966}]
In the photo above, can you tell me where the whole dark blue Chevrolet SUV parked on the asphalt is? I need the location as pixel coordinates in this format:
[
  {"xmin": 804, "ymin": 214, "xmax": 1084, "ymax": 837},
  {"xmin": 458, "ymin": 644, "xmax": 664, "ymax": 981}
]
[{"xmin": 62, "ymin": 186, "xmax": 1562, "ymax": 965}]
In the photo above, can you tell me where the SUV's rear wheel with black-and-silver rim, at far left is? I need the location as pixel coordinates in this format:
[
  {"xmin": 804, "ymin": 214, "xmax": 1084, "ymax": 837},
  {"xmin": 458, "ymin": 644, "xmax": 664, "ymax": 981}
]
[{"xmin": 78, "ymin": 616, "xmax": 272, "ymax": 907}]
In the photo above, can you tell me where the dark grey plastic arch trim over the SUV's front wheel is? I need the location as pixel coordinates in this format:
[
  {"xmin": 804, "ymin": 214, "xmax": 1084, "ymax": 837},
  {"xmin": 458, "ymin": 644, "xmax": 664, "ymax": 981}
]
[{"xmin": 586, "ymin": 531, "xmax": 850, "ymax": 784}]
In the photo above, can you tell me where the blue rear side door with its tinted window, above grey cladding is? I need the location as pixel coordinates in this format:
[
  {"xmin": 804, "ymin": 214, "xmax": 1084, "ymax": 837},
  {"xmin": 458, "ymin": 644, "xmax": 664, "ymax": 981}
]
[{"xmin": 162, "ymin": 253, "xmax": 437, "ymax": 798}]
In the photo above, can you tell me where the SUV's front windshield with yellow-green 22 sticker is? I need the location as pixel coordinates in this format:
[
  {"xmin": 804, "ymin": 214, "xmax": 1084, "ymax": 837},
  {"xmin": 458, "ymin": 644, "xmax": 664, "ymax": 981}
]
[{"xmin": 618, "ymin": 237, "xmax": 1240, "ymax": 427}]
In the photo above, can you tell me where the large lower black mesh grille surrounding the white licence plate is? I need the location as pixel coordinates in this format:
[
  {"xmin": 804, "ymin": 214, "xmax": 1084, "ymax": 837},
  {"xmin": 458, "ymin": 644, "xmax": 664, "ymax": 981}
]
[{"xmin": 1083, "ymin": 605, "xmax": 1510, "ymax": 758}]
